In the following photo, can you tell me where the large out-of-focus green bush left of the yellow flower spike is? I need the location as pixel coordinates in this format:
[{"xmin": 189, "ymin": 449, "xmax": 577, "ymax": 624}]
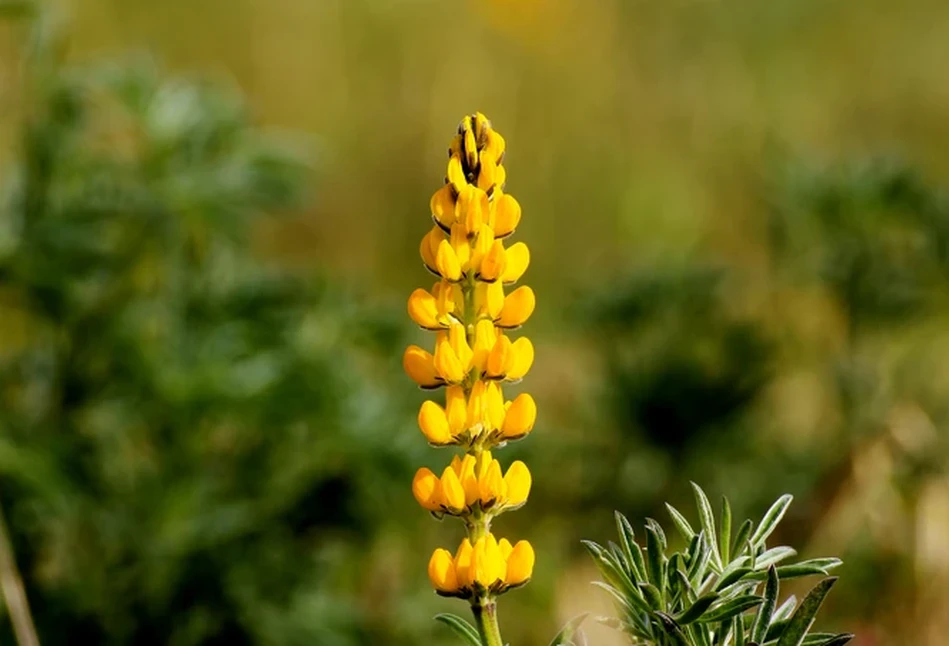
[{"xmin": 0, "ymin": 11, "xmax": 426, "ymax": 645}]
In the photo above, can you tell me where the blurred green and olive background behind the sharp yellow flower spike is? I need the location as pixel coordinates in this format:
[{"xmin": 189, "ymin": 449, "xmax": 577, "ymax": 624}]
[{"xmin": 0, "ymin": 0, "xmax": 949, "ymax": 646}]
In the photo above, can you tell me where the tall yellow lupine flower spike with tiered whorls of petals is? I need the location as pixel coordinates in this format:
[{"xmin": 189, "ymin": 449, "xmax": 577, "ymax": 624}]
[{"xmin": 403, "ymin": 113, "xmax": 537, "ymax": 608}]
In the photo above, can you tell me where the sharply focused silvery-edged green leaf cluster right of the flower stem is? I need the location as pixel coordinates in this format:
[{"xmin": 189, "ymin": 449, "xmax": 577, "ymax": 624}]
[{"xmin": 585, "ymin": 483, "xmax": 853, "ymax": 646}]
